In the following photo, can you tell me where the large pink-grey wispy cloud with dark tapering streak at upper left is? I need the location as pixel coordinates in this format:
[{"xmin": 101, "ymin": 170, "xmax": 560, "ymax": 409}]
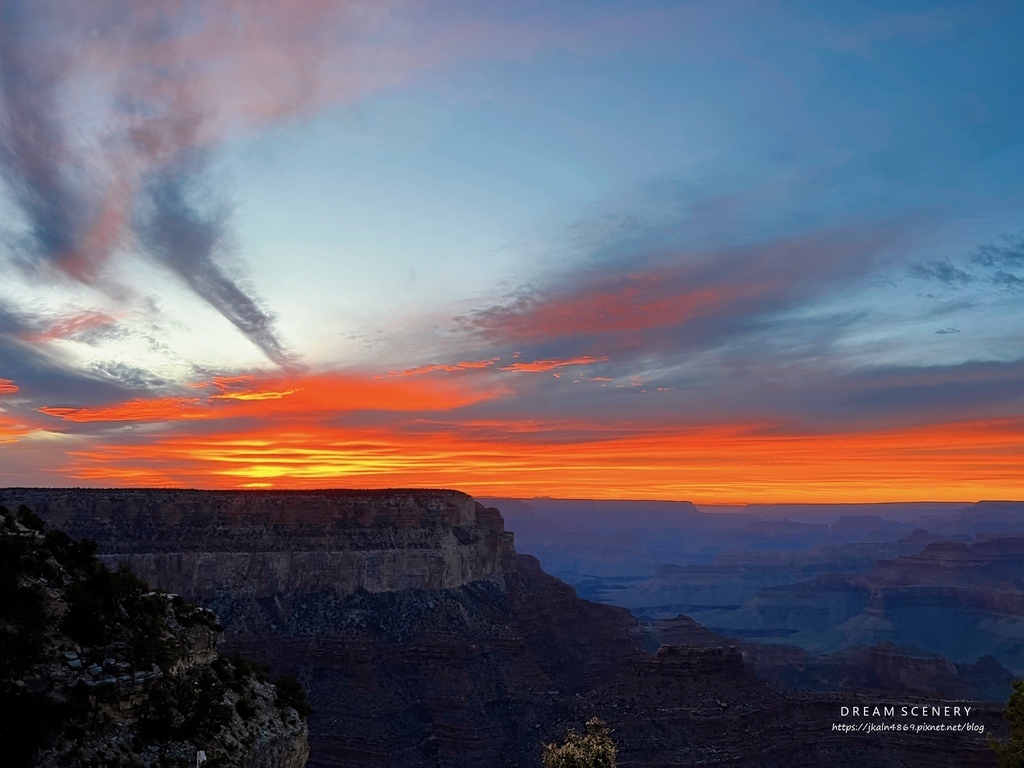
[{"xmin": 0, "ymin": 0, "xmax": 417, "ymax": 368}]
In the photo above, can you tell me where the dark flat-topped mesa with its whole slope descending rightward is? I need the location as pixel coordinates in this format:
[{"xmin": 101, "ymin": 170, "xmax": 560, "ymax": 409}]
[{"xmin": 0, "ymin": 488, "xmax": 999, "ymax": 768}]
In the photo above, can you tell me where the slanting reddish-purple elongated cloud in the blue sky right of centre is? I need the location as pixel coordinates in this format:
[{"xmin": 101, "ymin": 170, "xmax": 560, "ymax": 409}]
[{"xmin": 457, "ymin": 222, "xmax": 895, "ymax": 358}]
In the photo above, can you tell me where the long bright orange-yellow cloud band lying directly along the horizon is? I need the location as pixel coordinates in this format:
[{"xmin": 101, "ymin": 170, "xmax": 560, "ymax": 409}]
[{"xmin": 49, "ymin": 419, "xmax": 1024, "ymax": 504}]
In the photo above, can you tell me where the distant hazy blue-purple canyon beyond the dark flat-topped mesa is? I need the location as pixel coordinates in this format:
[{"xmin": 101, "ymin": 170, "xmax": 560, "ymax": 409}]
[{"xmin": 492, "ymin": 499, "xmax": 1024, "ymax": 684}]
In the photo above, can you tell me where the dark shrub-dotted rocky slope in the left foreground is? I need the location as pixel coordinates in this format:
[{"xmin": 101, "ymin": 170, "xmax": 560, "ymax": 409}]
[{"xmin": 0, "ymin": 507, "xmax": 309, "ymax": 768}]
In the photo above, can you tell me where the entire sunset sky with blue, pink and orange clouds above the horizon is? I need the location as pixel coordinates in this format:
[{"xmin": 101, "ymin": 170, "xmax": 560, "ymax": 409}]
[{"xmin": 0, "ymin": 0, "xmax": 1024, "ymax": 504}]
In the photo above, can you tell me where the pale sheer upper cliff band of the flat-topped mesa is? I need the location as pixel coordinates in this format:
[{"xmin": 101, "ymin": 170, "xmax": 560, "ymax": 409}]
[{"xmin": 0, "ymin": 488, "xmax": 515, "ymax": 601}]
